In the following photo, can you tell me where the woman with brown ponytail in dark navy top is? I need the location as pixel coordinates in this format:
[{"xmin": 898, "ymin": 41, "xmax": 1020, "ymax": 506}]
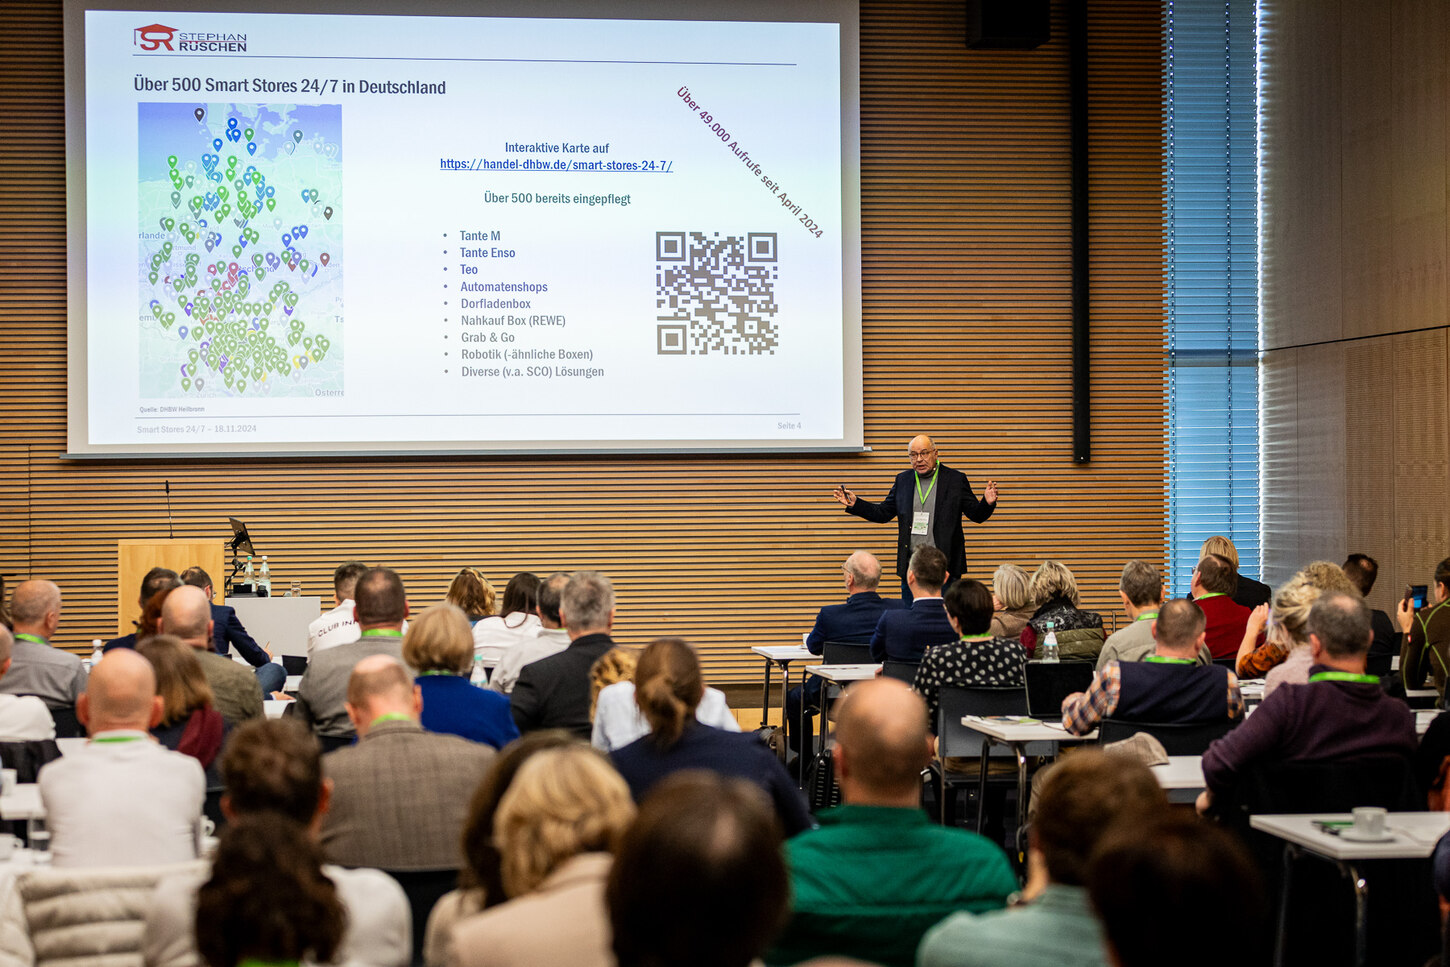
[{"xmin": 612, "ymin": 638, "xmax": 811, "ymax": 835}]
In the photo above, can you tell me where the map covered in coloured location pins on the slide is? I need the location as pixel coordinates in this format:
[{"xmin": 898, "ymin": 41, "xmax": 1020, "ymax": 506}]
[{"xmin": 138, "ymin": 103, "xmax": 344, "ymax": 399}]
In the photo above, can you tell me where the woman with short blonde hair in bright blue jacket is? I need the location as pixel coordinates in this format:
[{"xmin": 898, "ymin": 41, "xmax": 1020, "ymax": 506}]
[{"xmin": 403, "ymin": 605, "xmax": 519, "ymax": 748}]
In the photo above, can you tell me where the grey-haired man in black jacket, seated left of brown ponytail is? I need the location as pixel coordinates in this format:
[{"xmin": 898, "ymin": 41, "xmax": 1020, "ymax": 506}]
[{"xmin": 509, "ymin": 571, "xmax": 615, "ymax": 741}]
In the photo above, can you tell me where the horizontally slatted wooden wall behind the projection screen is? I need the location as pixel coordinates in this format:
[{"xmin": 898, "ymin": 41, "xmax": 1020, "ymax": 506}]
[{"xmin": 0, "ymin": 0, "xmax": 1164, "ymax": 683}]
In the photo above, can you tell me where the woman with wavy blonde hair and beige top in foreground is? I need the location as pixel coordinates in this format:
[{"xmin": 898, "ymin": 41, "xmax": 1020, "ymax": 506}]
[{"xmin": 447, "ymin": 744, "xmax": 635, "ymax": 967}]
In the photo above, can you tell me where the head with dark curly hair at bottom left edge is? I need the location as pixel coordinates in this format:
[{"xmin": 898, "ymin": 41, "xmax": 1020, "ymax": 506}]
[{"xmin": 194, "ymin": 816, "xmax": 348, "ymax": 967}]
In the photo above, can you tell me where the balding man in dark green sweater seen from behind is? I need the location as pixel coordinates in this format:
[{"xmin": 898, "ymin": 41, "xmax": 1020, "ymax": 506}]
[{"xmin": 766, "ymin": 678, "xmax": 1016, "ymax": 967}]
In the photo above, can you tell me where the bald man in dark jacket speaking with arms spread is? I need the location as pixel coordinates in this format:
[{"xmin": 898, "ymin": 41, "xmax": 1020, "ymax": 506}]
[{"xmin": 831, "ymin": 433, "xmax": 996, "ymax": 602}]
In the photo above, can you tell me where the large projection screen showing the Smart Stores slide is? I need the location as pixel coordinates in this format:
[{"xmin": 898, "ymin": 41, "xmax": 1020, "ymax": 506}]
[{"xmin": 68, "ymin": 9, "xmax": 861, "ymax": 457}]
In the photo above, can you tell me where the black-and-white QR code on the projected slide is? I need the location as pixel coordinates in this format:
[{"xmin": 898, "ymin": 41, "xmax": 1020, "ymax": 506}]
[{"xmin": 654, "ymin": 232, "xmax": 780, "ymax": 355}]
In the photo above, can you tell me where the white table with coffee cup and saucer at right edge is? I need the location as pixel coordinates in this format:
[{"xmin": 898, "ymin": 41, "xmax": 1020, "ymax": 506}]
[{"xmin": 1248, "ymin": 812, "xmax": 1450, "ymax": 964}]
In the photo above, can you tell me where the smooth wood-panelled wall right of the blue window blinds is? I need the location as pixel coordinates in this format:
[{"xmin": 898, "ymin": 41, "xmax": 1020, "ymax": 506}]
[{"xmin": 1263, "ymin": 0, "xmax": 1450, "ymax": 609}]
